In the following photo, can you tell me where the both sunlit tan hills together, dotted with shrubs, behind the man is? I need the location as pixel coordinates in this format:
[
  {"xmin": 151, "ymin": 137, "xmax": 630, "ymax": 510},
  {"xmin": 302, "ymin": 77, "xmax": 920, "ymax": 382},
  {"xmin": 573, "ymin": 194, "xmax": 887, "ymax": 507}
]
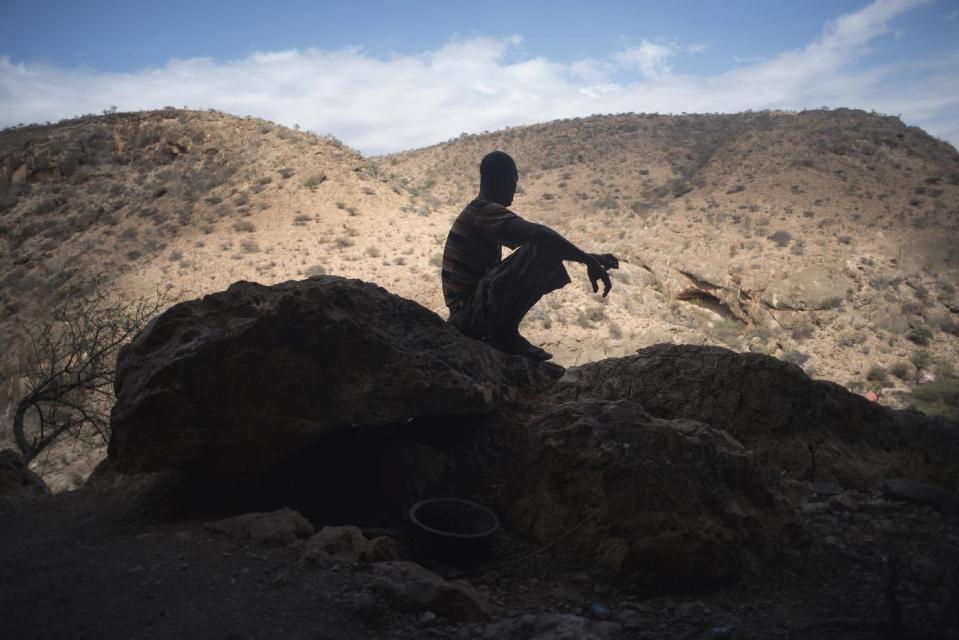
[{"xmin": 0, "ymin": 109, "xmax": 959, "ymax": 488}]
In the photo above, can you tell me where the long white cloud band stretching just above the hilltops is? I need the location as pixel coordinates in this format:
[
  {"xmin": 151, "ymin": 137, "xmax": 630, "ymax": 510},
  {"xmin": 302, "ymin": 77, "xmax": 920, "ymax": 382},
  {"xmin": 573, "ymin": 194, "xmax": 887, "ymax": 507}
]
[{"xmin": 0, "ymin": 0, "xmax": 959, "ymax": 153}]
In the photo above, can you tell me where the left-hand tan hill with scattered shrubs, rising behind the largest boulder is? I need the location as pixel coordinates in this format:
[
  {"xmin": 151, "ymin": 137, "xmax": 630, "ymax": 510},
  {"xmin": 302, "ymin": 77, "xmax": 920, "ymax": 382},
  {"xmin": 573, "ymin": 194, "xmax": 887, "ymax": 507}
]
[{"xmin": 0, "ymin": 109, "xmax": 454, "ymax": 486}]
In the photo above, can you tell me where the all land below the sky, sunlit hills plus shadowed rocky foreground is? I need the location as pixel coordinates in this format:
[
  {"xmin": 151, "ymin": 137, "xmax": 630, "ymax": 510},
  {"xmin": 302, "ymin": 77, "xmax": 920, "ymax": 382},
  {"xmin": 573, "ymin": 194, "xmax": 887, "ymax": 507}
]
[{"xmin": 0, "ymin": 108, "xmax": 959, "ymax": 640}]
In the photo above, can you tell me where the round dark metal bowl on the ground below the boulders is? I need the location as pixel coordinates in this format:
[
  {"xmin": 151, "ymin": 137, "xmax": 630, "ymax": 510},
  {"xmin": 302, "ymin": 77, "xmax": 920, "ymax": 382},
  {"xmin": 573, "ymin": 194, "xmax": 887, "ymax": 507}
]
[{"xmin": 410, "ymin": 498, "xmax": 499, "ymax": 567}]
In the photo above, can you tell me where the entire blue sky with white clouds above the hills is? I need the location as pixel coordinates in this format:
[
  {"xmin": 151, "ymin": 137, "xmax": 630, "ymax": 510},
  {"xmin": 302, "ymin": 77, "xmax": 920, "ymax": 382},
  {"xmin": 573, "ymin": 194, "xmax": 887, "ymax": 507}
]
[{"xmin": 0, "ymin": 0, "xmax": 959, "ymax": 154}]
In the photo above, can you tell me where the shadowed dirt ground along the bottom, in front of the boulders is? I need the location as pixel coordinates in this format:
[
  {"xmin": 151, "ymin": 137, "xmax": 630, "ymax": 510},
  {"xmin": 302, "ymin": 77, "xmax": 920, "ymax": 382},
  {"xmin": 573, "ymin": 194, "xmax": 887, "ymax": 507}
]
[{"xmin": 0, "ymin": 476, "xmax": 959, "ymax": 640}]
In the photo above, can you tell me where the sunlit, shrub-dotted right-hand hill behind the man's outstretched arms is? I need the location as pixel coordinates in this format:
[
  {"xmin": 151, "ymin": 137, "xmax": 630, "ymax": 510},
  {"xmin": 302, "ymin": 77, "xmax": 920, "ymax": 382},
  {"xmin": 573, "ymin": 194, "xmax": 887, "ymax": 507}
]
[{"xmin": 378, "ymin": 109, "xmax": 959, "ymax": 387}]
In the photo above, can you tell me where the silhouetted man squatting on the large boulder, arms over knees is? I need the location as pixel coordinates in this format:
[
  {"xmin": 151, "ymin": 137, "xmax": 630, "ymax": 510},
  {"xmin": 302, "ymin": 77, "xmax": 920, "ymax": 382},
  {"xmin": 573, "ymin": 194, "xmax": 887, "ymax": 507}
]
[{"xmin": 443, "ymin": 151, "xmax": 619, "ymax": 360}]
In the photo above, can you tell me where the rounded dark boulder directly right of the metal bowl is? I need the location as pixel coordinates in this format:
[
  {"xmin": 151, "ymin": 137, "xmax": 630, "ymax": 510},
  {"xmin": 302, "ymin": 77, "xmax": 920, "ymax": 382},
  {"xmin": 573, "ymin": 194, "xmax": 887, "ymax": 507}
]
[{"xmin": 496, "ymin": 400, "xmax": 798, "ymax": 591}]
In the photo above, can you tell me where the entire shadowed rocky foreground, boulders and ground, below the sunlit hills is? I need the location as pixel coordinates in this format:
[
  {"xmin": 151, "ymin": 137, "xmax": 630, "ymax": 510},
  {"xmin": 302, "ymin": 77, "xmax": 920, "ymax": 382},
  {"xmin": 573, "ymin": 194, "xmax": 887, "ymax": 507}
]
[{"xmin": 0, "ymin": 276, "xmax": 959, "ymax": 640}]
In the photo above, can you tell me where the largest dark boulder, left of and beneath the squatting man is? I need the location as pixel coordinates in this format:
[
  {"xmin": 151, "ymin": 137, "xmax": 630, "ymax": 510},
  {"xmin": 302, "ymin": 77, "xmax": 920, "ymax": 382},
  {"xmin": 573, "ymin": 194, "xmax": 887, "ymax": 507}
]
[{"xmin": 109, "ymin": 276, "xmax": 561, "ymax": 473}]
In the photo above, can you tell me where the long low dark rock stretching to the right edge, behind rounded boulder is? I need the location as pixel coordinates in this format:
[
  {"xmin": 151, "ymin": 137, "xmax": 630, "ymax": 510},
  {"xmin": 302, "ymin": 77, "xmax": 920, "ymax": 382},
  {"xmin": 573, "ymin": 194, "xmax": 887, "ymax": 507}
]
[{"xmin": 543, "ymin": 344, "xmax": 959, "ymax": 486}]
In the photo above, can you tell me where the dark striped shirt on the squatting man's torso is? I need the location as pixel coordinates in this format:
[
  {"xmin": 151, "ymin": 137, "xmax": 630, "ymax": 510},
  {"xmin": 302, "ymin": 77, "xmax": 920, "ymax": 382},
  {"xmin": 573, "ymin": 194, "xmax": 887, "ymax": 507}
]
[{"xmin": 443, "ymin": 198, "xmax": 519, "ymax": 307}]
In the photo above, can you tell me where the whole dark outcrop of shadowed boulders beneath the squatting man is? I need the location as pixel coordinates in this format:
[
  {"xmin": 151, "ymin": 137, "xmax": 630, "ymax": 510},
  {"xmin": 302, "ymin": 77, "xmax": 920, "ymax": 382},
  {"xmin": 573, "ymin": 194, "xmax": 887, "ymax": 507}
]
[{"xmin": 101, "ymin": 277, "xmax": 959, "ymax": 596}]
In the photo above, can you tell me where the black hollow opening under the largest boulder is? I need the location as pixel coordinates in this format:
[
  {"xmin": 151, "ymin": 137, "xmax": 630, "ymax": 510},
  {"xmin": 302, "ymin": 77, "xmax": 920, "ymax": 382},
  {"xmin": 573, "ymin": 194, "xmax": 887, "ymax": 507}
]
[{"xmin": 148, "ymin": 415, "xmax": 484, "ymax": 528}]
